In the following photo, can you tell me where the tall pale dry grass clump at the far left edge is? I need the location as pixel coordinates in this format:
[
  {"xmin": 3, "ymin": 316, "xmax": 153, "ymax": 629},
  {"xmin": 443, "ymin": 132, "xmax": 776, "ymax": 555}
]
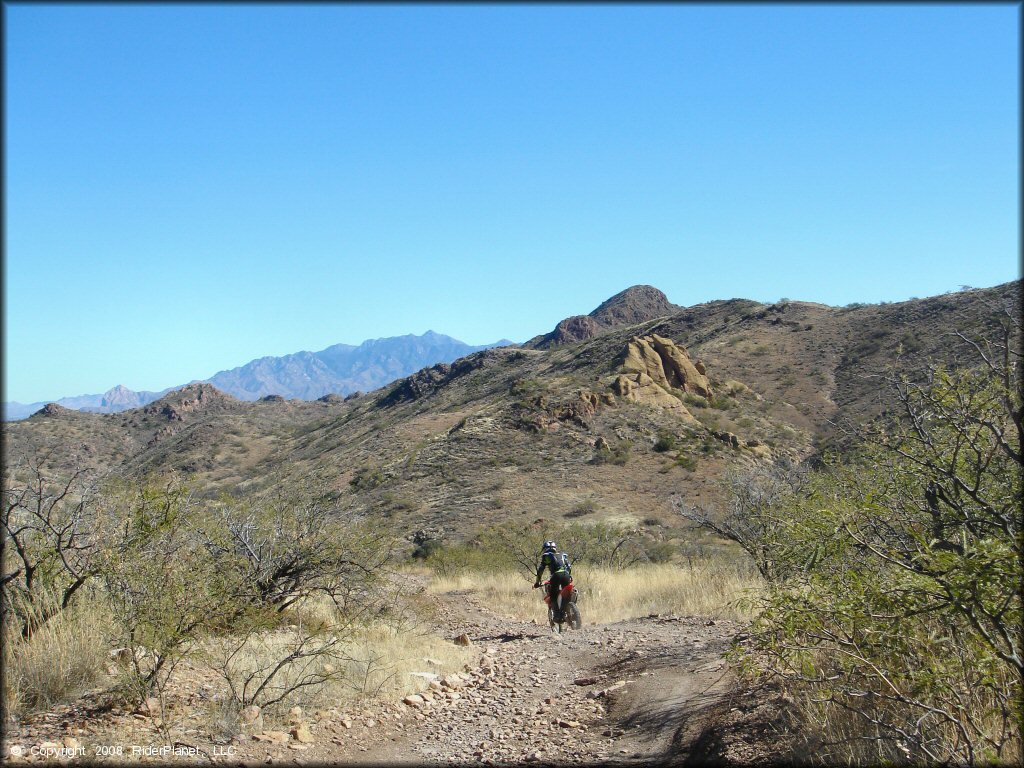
[{"xmin": 3, "ymin": 594, "xmax": 111, "ymax": 715}]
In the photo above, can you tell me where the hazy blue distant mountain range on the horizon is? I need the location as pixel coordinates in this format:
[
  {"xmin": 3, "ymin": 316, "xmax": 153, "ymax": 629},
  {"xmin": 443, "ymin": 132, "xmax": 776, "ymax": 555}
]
[{"xmin": 3, "ymin": 331, "xmax": 514, "ymax": 421}]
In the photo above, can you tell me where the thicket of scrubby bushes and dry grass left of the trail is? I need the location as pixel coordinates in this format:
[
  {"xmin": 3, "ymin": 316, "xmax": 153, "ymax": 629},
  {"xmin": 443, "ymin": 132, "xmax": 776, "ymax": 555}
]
[{"xmin": 4, "ymin": 468, "xmax": 396, "ymax": 729}]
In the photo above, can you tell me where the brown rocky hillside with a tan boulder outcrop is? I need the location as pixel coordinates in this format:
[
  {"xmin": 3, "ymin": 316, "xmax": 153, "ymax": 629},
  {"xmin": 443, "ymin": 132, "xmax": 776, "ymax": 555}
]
[{"xmin": 4, "ymin": 282, "xmax": 1021, "ymax": 546}]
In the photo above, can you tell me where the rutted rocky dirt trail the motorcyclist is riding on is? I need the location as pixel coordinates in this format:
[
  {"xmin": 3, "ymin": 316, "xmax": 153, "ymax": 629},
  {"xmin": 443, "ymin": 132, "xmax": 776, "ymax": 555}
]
[{"xmin": 288, "ymin": 593, "xmax": 739, "ymax": 765}]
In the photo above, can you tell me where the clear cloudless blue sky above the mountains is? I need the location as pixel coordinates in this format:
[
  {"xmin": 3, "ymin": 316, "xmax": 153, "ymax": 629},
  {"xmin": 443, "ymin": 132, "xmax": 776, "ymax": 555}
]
[{"xmin": 4, "ymin": 4, "xmax": 1020, "ymax": 401}]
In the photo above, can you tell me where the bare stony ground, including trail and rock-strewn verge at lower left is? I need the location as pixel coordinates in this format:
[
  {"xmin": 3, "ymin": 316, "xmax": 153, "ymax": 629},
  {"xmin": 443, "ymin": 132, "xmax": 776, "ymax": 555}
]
[{"xmin": 4, "ymin": 593, "xmax": 774, "ymax": 766}]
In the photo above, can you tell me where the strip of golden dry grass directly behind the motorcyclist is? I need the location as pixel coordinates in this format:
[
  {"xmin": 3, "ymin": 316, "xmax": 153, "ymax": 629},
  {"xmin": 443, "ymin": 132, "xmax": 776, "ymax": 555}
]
[{"xmin": 430, "ymin": 560, "xmax": 760, "ymax": 624}]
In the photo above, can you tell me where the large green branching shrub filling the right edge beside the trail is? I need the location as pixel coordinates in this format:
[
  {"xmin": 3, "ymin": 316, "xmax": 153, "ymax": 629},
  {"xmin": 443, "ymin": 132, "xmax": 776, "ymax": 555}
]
[{"xmin": 687, "ymin": 311, "xmax": 1024, "ymax": 765}]
